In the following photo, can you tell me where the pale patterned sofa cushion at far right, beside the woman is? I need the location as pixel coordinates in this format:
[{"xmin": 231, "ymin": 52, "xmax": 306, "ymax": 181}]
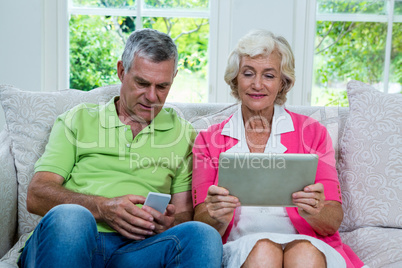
[{"xmin": 338, "ymin": 81, "xmax": 402, "ymax": 231}]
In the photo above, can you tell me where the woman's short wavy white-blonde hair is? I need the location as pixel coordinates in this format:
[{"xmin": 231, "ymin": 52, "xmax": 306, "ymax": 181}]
[{"xmin": 225, "ymin": 30, "xmax": 296, "ymax": 105}]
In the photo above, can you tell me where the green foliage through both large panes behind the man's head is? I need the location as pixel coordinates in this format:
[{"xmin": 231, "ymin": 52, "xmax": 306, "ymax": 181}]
[{"xmin": 70, "ymin": 15, "xmax": 209, "ymax": 94}]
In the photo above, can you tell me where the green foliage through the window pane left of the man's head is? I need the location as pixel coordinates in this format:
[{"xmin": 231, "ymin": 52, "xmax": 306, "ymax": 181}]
[{"xmin": 70, "ymin": 15, "xmax": 121, "ymax": 91}]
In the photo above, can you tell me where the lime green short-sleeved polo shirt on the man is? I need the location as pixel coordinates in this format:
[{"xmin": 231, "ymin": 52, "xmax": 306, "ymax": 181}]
[{"xmin": 35, "ymin": 97, "xmax": 196, "ymax": 232}]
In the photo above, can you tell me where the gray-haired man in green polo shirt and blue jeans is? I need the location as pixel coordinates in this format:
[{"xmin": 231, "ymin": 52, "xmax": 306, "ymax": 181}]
[{"xmin": 19, "ymin": 29, "xmax": 222, "ymax": 267}]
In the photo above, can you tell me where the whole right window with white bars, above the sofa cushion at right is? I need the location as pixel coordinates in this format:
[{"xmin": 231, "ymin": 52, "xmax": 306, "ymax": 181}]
[{"xmin": 311, "ymin": 0, "xmax": 402, "ymax": 106}]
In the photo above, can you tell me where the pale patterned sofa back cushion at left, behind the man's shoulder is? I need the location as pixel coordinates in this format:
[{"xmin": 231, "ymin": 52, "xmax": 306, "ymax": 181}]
[{"xmin": 0, "ymin": 85, "xmax": 120, "ymax": 236}]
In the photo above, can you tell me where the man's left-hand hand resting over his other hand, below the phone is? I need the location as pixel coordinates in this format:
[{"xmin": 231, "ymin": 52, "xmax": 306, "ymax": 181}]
[{"xmin": 98, "ymin": 195, "xmax": 159, "ymax": 240}]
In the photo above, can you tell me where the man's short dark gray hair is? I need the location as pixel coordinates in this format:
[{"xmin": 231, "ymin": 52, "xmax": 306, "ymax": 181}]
[{"xmin": 121, "ymin": 29, "xmax": 178, "ymax": 73}]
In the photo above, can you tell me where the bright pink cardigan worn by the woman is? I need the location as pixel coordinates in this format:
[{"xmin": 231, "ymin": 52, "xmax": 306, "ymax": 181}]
[{"xmin": 192, "ymin": 110, "xmax": 364, "ymax": 267}]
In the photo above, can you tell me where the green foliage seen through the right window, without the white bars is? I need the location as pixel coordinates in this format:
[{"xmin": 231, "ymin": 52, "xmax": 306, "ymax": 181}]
[{"xmin": 313, "ymin": 1, "xmax": 402, "ymax": 106}]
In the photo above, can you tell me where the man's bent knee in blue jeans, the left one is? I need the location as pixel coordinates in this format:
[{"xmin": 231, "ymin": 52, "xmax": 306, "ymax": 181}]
[{"xmin": 19, "ymin": 204, "xmax": 98, "ymax": 267}]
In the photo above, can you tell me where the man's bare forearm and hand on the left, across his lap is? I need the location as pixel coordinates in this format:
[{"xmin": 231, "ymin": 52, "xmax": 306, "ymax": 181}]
[{"xmin": 27, "ymin": 172, "xmax": 155, "ymax": 240}]
